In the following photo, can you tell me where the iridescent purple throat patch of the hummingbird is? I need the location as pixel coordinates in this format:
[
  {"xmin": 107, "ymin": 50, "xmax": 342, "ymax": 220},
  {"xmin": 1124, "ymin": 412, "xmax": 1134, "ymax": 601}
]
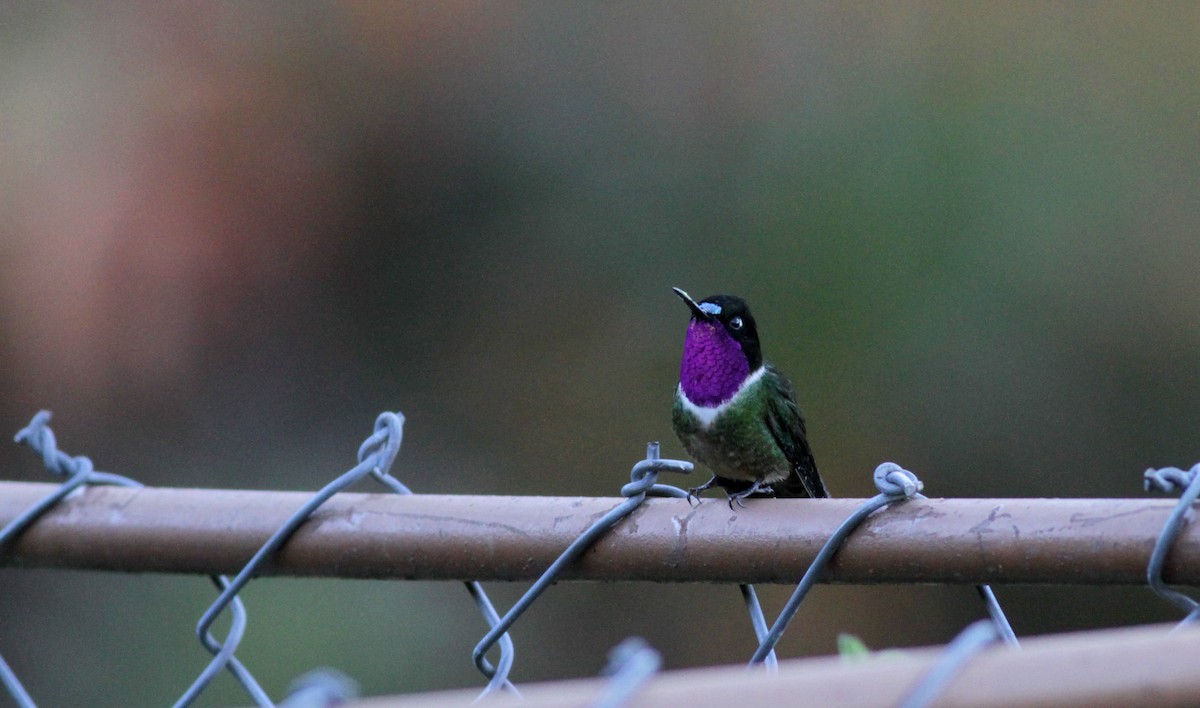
[{"xmin": 679, "ymin": 319, "xmax": 750, "ymax": 407}]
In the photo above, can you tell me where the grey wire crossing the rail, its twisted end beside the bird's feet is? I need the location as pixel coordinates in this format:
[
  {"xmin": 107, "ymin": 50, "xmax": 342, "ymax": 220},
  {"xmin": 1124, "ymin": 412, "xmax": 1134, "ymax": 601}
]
[{"xmin": 472, "ymin": 443, "xmax": 692, "ymax": 697}]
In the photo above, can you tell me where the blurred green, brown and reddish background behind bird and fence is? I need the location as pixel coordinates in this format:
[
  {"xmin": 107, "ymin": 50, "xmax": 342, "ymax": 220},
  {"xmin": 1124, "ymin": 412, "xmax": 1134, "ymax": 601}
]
[{"xmin": 0, "ymin": 1, "xmax": 1200, "ymax": 706}]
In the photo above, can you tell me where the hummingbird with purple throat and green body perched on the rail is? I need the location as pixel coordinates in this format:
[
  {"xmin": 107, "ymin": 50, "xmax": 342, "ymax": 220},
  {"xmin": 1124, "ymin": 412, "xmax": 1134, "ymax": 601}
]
[{"xmin": 671, "ymin": 288, "xmax": 829, "ymax": 506}]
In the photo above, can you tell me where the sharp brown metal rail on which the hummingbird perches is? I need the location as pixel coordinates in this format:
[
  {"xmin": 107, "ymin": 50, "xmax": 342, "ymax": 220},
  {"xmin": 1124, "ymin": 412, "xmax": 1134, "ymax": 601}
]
[{"xmin": 0, "ymin": 482, "xmax": 1200, "ymax": 586}]
